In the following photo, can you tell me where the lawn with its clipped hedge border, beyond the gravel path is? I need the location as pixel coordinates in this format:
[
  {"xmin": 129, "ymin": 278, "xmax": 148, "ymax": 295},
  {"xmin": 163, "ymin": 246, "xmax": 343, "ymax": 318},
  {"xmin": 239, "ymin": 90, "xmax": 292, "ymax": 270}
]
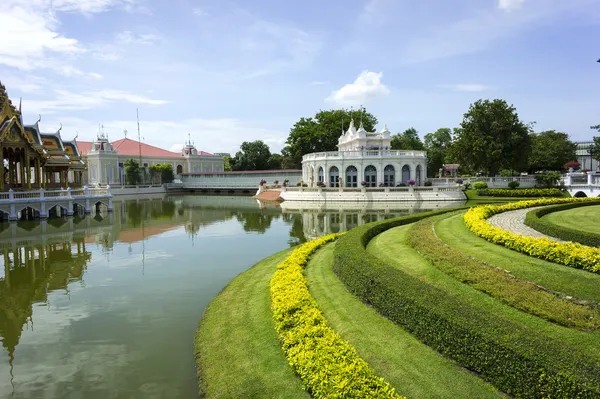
[{"xmin": 525, "ymin": 202, "xmax": 600, "ymax": 247}]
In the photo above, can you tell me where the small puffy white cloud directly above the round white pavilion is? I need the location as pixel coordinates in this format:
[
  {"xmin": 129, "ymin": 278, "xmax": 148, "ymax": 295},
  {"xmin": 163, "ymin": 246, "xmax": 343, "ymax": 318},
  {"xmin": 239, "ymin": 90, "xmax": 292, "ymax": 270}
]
[{"xmin": 325, "ymin": 71, "xmax": 390, "ymax": 105}]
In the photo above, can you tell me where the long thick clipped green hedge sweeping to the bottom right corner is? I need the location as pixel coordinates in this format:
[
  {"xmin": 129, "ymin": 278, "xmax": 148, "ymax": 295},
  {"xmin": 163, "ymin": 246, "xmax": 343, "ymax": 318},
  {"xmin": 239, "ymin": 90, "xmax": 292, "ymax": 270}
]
[{"xmin": 334, "ymin": 210, "xmax": 600, "ymax": 398}]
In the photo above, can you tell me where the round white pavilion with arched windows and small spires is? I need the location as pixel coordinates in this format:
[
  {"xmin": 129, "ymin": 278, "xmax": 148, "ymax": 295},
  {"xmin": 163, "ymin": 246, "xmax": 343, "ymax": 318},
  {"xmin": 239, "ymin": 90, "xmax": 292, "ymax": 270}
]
[{"xmin": 302, "ymin": 120, "xmax": 427, "ymax": 187}]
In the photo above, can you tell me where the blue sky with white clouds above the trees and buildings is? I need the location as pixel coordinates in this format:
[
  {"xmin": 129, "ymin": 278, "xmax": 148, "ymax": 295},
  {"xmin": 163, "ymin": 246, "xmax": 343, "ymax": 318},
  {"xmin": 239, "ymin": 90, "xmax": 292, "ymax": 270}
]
[{"xmin": 0, "ymin": 0, "xmax": 600, "ymax": 154}]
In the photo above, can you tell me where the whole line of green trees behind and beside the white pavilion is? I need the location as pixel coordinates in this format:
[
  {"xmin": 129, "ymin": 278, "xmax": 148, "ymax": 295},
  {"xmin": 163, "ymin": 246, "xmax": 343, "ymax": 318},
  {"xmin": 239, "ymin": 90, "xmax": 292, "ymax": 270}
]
[{"xmin": 226, "ymin": 99, "xmax": 600, "ymax": 176}]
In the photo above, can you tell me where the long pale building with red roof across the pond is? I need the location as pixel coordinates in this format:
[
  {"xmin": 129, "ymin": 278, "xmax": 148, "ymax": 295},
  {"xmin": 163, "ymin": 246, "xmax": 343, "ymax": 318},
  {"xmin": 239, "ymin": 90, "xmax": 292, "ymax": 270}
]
[{"xmin": 77, "ymin": 134, "xmax": 225, "ymax": 185}]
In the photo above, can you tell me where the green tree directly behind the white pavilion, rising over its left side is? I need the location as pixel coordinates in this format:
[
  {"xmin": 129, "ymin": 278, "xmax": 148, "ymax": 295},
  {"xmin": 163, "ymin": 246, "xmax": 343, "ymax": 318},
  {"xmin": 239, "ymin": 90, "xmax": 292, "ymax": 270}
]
[{"xmin": 282, "ymin": 108, "xmax": 377, "ymax": 169}]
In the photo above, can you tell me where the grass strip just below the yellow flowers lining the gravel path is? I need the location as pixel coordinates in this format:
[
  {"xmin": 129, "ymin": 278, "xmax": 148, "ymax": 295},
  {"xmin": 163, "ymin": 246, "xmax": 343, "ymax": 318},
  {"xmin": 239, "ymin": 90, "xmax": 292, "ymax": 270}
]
[{"xmin": 435, "ymin": 215, "xmax": 600, "ymax": 304}]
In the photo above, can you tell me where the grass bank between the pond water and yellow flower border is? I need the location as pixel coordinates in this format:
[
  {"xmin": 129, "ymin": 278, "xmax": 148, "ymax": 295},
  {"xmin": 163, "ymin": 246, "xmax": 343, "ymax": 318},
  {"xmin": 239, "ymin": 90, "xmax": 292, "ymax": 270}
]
[{"xmin": 194, "ymin": 250, "xmax": 310, "ymax": 399}]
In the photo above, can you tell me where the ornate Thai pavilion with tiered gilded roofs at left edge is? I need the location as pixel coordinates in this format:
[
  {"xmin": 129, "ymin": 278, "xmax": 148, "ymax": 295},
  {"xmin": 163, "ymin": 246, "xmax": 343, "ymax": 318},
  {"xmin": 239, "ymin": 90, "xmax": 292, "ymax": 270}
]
[{"xmin": 0, "ymin": 84, "xmax": 85, "ymax": 190}]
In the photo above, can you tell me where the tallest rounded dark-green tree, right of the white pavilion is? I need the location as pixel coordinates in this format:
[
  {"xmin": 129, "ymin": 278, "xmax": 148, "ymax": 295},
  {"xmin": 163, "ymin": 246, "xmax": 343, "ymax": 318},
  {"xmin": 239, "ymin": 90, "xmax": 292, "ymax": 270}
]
[{"xmin": 452, "ymin": 99, "xmax": 531, "ymax": 176}]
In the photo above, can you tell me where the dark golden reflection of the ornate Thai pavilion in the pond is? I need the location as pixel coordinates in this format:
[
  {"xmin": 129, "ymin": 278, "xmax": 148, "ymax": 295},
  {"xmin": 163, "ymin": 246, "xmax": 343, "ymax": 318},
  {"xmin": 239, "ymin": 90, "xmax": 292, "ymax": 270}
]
[{"xmin": 0, "ymin": 238, "xmax": 92, "ymax": 362}]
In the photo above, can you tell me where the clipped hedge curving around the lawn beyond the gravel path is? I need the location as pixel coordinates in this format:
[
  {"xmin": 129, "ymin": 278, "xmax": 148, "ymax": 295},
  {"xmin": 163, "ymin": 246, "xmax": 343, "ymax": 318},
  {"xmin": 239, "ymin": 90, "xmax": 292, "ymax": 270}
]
[{"xmin": 525, "ymin": 201, "xmax": 600, "ymax": 247}]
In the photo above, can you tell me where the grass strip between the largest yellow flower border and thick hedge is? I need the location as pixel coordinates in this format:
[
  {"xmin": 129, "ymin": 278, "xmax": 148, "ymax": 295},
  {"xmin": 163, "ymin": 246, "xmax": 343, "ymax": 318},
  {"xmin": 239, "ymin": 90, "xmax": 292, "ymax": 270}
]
[{"xmin": 306, "ymin": 244, "xmax": 502, "ymax": 399}]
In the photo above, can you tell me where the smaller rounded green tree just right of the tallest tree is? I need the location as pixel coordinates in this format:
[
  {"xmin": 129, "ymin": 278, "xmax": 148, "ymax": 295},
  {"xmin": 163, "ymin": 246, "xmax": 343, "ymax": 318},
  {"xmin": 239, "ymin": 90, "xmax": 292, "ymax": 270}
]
[{"xmin": 528, "ymin": 130, "xmax": 577, "ymax": 173}]
